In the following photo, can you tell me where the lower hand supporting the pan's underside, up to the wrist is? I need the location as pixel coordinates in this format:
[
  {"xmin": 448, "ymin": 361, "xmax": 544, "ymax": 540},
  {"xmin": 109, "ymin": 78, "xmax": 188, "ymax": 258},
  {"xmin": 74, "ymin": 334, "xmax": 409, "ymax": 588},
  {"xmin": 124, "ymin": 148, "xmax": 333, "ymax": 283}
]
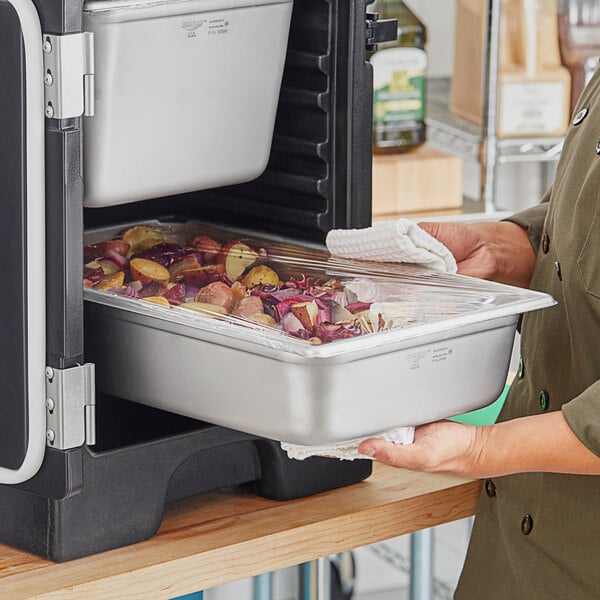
[{"xmin": 358, "ymin": 421, "xmax": 485, "ymax": 477}]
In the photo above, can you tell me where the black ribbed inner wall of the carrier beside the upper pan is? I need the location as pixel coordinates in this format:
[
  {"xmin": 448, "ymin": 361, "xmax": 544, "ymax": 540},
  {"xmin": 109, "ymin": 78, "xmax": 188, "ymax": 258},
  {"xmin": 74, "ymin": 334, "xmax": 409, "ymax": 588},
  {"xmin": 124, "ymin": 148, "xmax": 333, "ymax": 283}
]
[{"xmin": 86, "ymin": 0, "xmax": 372, "ymax": 240}]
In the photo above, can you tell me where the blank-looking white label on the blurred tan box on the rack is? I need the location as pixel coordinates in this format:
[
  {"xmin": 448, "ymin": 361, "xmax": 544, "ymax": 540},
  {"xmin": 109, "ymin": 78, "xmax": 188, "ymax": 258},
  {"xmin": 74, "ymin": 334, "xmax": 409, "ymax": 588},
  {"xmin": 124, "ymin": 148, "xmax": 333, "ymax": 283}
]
[{"xmin": 499, "ymin": 81, "xmax": 567, "ymax": 136}]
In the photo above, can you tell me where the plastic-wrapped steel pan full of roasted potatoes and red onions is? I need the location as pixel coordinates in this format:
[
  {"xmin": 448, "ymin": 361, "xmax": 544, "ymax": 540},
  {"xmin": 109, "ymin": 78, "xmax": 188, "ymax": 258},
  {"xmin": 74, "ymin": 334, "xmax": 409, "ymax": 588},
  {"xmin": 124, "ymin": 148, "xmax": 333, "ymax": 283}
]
[{"xmin": 84, "ymin": 222, "xmax": 554, "ymax": 444}]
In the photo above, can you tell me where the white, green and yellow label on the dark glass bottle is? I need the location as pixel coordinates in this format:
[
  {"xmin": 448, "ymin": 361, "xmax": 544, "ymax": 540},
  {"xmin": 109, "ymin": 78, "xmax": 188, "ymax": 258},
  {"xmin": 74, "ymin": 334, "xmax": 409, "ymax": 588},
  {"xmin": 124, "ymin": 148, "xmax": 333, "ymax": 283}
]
[{"xmin": 371, "ymin": 48, "xmax": 427, "ymax": 124}]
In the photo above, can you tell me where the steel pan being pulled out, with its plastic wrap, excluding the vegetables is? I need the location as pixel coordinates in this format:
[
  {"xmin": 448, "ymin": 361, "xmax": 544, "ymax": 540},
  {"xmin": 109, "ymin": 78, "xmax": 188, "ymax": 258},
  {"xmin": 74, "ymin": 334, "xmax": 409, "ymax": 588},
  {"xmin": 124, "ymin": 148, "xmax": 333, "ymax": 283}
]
[{"xmin": 85, "ymin": 222, "xmax": 555, "ymax": 445}]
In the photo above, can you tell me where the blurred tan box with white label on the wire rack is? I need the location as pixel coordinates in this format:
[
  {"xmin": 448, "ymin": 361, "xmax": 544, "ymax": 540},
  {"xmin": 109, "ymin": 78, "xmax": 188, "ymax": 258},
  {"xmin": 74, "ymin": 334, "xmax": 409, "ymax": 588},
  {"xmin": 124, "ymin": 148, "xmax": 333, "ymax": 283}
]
[{"xmin": 450, "ymin": 0, "xmax": 571, "ymax": 138}]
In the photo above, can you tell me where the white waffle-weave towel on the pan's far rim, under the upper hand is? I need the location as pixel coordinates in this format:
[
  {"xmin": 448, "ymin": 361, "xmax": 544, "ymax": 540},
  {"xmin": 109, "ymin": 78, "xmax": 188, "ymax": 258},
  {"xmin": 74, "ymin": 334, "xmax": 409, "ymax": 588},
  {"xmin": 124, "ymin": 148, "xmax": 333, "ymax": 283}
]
[{"xmin": 327, "ymin": 219, "xmax": 457, "ymax": 273}]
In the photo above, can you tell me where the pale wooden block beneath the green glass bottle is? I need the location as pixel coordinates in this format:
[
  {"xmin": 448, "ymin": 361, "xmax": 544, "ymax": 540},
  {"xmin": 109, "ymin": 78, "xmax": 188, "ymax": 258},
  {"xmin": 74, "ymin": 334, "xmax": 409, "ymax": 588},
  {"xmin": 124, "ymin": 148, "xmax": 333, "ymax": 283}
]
[{"xmin": 373, "ymin": 145, "xmax": 463, "ymax": 217}]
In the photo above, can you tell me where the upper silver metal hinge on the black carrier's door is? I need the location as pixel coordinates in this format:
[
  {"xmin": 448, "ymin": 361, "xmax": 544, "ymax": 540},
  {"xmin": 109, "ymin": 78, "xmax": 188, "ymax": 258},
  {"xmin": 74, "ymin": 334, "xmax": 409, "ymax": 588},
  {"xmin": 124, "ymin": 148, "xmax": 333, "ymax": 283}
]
[{"xmin": 42, "ymin": 31, "xmax": 94, "ymax": 119}]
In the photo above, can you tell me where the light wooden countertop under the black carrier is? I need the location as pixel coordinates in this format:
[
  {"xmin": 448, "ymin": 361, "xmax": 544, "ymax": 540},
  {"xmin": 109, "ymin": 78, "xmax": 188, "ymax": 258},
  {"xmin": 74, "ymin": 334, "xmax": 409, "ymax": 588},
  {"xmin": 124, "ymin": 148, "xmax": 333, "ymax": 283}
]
[{"xmin": 0, "ymin": 464, "xmax": 481, "ymax": 600}]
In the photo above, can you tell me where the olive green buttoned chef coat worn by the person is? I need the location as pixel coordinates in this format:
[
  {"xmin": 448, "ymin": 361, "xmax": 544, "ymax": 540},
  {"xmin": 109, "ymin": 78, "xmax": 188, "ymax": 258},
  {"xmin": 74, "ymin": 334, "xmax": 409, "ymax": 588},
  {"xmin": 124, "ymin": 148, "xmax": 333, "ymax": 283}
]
[{"xmin": 455, "ymin": 72, "xmax": 600, "ymax": 600}]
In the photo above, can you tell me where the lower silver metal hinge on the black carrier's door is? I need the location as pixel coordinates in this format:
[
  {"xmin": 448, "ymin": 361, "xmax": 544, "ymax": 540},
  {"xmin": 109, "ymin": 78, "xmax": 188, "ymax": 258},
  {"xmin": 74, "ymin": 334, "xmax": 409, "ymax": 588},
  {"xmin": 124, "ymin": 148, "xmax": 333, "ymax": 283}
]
[{"xmin": 46, "ymin": 363, "xmax": 96, "ymax": 450}]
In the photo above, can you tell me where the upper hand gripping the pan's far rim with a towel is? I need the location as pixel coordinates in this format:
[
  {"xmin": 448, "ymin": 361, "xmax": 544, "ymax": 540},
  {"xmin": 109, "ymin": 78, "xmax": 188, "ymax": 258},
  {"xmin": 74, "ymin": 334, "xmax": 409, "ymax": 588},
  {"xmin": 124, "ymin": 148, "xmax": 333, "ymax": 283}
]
[{"xmin": 419, "ymin": 222, "xmax": 535, "ymax": 287}]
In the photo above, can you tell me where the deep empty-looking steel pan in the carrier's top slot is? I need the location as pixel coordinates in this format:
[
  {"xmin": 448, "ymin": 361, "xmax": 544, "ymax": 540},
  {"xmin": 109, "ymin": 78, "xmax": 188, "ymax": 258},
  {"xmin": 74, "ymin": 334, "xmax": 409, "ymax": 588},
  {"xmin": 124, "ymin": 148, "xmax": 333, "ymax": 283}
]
[{"xmin": 84, "ymin": 0, "xmax": 293, "ymax": 207}]
